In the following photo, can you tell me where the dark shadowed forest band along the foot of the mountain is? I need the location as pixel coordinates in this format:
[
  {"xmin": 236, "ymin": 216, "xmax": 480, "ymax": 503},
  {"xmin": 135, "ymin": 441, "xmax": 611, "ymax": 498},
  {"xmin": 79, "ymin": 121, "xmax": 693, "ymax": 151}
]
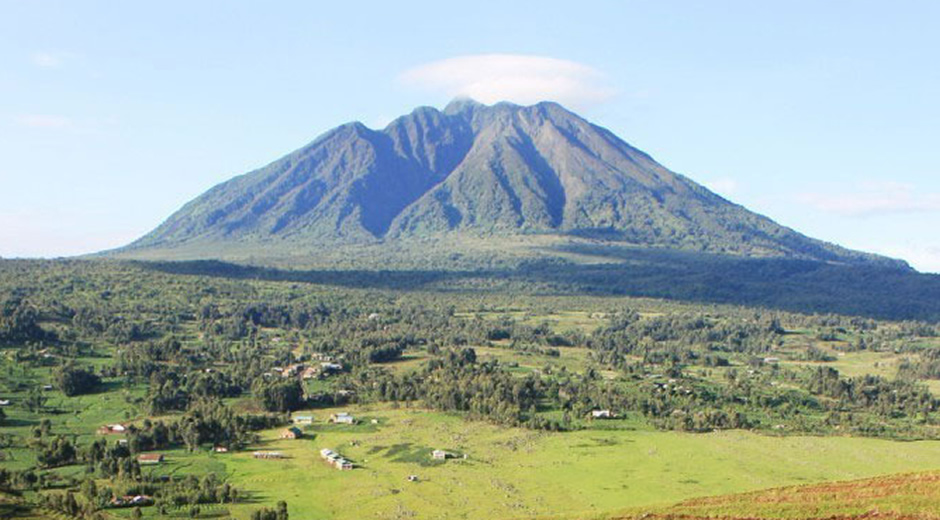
[{"xmin": 134, "ymin": 239, "xmax": 940, "ymax": 322}]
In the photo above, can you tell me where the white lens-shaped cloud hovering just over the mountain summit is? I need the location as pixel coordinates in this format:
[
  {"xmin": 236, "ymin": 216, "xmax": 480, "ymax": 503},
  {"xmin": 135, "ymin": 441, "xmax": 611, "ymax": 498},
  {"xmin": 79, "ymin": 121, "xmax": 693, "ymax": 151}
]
[{"xmin": 399, "ymin": 54, "xmax": 615, "ymax": 108}]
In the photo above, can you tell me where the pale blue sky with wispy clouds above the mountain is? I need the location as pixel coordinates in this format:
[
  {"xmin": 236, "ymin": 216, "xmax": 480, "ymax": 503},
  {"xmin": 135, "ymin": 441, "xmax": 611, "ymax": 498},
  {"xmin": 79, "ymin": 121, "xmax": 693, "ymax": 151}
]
[{"xmin": 0, "ymin": 0, "xmax": 940, "ymax": 272}]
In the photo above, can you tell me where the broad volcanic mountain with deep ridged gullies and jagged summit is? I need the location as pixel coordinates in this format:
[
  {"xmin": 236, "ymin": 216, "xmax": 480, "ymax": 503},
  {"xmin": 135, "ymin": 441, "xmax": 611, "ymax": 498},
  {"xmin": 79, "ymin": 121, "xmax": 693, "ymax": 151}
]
[{"xmin": 117, "ymin": 100, "xmax": 904, "ymax": 267}]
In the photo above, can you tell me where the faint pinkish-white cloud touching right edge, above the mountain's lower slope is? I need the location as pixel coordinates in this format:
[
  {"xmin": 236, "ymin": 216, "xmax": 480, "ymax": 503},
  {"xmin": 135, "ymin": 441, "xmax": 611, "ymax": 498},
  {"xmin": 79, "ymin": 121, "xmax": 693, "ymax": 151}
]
[{"xmin": 800, "ymin": 182, "xmax": 940, "ymax": 217}]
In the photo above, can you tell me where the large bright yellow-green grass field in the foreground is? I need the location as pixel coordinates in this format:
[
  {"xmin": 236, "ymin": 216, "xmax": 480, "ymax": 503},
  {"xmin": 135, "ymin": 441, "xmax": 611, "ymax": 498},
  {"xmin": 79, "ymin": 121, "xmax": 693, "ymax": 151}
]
[{"xmin": 123, "ymin": 407, "xmax": 940, "ymax": 519}]
